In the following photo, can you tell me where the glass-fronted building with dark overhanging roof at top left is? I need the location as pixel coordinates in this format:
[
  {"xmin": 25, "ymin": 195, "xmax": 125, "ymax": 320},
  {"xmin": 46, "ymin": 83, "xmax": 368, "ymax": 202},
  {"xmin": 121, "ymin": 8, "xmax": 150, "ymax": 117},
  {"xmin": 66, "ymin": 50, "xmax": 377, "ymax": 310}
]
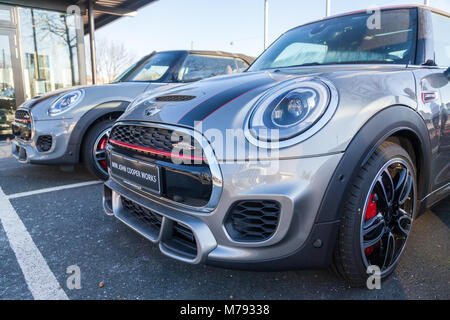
[{"xmin": 0, "ymin": 0, "xmax": 155, "ymax": 139}]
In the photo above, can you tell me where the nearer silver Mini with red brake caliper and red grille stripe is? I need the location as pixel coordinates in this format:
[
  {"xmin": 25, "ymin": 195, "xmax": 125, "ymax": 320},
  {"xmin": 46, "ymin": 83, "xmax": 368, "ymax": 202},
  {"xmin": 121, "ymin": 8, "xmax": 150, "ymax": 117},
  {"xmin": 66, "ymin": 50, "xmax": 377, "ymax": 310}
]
[{"xmin": 104, "ymin": 6, "xmax": 450, "ymax": 285}]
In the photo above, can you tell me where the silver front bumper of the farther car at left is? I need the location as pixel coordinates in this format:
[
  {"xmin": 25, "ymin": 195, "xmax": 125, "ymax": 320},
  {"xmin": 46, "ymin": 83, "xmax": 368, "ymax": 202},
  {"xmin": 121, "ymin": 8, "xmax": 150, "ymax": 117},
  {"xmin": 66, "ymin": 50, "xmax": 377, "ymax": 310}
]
[{"xmin": 11, "ymin": 119, "xmax": 78, "ymax": 164}]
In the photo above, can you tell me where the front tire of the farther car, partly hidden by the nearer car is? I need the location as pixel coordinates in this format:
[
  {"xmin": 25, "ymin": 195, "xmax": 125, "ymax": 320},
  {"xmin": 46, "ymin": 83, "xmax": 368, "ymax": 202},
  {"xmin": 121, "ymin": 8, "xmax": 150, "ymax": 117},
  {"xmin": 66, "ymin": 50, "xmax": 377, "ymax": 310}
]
[{"xmin": 82, "ymin": 120, "xmax": 114, "ymax": 180}]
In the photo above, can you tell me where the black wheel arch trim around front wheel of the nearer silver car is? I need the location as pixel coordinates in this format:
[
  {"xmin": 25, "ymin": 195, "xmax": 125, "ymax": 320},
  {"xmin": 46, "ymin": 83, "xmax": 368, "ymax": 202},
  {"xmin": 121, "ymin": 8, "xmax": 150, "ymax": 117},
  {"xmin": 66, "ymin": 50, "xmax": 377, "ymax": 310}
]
[{"xmin": 316, "ymin": 105, "xmax": 431, "ymax": 223}]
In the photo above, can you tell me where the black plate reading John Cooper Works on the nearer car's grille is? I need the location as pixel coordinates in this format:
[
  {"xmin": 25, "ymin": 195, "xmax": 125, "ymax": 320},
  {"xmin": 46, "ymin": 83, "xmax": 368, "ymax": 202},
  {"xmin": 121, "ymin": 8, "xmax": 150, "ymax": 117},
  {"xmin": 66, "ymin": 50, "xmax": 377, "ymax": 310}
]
[{"xmin": 110, "ymin": 153, "xmax": 161, "ymax": 194}]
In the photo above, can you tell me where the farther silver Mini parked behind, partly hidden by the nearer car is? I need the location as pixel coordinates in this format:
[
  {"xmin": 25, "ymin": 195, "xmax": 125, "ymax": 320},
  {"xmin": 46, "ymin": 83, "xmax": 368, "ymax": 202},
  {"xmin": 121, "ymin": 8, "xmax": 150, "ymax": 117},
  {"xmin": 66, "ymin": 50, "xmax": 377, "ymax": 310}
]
[{"xmin": 11, "ymin": 50, "xmax": 253, "ymax": 179}]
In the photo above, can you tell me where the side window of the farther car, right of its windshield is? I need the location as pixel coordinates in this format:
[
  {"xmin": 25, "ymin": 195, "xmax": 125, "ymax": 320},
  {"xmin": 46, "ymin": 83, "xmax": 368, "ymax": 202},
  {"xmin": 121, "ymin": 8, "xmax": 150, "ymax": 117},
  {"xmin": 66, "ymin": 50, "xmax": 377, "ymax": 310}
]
[{"xmin": 178, "ymin": 54, "xmax": 238, "ymax": 82}]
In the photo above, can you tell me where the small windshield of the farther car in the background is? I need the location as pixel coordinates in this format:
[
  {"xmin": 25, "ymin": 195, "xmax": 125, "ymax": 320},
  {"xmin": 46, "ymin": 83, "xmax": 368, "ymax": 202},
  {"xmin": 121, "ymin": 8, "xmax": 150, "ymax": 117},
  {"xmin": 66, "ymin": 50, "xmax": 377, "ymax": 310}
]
[{"xmin": 114, "ymin": 52, "xmax": 180, "ymax": 82}]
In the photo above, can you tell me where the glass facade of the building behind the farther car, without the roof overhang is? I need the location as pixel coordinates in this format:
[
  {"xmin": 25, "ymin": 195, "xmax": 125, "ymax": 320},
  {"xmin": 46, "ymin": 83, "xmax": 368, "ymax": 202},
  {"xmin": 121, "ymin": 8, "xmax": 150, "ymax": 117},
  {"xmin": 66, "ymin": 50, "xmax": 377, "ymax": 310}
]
[{"xmin": 0, "ymin": 5, "xmax": 85, "ymax": 140}]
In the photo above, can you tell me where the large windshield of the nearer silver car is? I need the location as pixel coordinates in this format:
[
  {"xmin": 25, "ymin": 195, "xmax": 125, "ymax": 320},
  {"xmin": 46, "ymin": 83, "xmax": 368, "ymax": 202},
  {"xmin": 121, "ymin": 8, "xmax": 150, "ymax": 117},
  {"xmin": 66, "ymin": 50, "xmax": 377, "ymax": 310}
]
[{"xmin": 249, "ymin": 9, "xmax": 417, "ymax": 71}]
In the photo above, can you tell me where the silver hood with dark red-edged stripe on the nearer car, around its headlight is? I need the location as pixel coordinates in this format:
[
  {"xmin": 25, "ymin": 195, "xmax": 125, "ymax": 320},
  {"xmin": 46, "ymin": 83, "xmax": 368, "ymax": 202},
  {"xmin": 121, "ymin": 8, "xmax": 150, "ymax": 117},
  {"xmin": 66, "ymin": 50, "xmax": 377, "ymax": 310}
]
[{"xmin": 119, "ymin": 65, "xmax": 417, "ymax": 158}]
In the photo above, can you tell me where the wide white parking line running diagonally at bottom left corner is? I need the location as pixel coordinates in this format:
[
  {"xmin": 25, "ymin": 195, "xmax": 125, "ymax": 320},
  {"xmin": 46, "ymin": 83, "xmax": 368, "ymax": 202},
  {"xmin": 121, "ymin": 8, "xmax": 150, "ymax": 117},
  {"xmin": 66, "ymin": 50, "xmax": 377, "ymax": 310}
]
[{"xmin": 0, "ymin": 187, "xmax": 69, "ymax": 300}]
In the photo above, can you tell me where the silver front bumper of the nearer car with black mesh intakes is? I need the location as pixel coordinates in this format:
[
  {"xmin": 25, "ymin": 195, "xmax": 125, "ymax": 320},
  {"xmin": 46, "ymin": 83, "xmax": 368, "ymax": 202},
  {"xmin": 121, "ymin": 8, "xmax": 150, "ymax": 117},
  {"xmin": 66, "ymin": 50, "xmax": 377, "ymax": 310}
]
[{"xmin": 103, "ymin": 153, "xmax": 342, "ymax": 269}]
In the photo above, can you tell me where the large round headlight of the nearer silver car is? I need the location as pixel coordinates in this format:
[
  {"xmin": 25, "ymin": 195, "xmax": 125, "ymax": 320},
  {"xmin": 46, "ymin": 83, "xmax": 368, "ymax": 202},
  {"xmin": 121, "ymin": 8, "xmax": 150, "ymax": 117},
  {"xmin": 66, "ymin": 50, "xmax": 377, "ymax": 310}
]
[{"xmin": 247, "ymin": 80, "xmax": 334, "ymax": 147}]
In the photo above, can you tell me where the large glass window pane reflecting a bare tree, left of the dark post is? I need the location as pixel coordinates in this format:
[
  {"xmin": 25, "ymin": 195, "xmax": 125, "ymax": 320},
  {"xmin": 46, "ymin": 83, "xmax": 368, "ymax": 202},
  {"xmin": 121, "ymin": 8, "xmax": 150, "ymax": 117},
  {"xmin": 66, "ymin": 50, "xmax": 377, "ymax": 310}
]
[{"xmin": 19, "ymin": 8, "xmax": 79, "ymax": 99}]
